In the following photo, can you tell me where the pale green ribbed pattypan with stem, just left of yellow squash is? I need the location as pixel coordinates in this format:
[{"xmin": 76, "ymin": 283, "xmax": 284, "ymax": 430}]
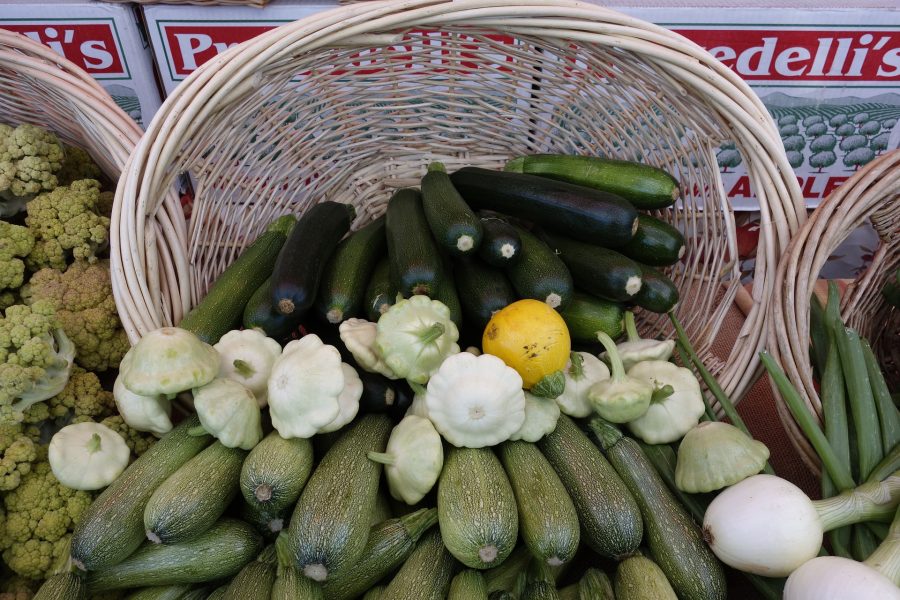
[{"xmin": 375, "ymin": 296, "xmax": 459, "ymax": 384}]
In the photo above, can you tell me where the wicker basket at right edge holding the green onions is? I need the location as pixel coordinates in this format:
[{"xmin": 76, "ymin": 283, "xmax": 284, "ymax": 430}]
[{"xmin": 769, "ymin": 150, "xmax": 900, "ymax": 474}]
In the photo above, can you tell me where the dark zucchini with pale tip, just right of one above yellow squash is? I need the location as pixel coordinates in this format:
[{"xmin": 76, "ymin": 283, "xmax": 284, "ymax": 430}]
[{"xmin": 541, "ymin": 232, "xmax": 642, "ymax": 302}]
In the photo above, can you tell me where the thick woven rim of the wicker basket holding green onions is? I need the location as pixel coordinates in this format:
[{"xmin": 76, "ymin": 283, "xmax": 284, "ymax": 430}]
[{"xmin": 768, "ymin": 149, "xmax": 900, "ymax": 476}]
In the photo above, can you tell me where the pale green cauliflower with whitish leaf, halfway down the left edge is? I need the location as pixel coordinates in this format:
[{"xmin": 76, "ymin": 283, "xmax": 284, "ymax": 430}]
[{"xmin": 0, "ymin": 300, "xmax": 75, "ymax": 420}]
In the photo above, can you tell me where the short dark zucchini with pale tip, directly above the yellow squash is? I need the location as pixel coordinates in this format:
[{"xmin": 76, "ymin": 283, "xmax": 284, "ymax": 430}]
[{"xmin": 506, "ymin": 227, "xmax": 574, "ymax": 309}]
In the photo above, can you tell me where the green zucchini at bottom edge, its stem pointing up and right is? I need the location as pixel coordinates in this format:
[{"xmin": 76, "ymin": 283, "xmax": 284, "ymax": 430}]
[{"xmin": 323, "ymin": 508, "xmax": 437, "ymax": 600}]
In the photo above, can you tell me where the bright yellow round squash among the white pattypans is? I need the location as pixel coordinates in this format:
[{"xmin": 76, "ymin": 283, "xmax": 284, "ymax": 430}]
[{"xmin": 481, "ymin": 300, "xmax": 572, "ymax": 390}]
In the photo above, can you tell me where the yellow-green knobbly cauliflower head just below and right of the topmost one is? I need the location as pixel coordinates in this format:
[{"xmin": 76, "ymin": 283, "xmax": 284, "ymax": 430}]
[{"xmin": 25, "ymin": 179, "xmax": 109, "ymax": 271}]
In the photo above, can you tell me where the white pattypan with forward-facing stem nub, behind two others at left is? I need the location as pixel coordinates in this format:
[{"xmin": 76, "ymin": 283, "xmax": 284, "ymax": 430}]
[{"xmin": 213, "ymin": 329, "xmax": 281, "ymax": 408}]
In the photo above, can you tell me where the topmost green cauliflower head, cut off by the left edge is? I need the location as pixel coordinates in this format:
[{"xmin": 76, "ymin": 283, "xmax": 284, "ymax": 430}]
[{"xmin": 0, "ymin": 123, "xmax": 63, "ymax": 216}]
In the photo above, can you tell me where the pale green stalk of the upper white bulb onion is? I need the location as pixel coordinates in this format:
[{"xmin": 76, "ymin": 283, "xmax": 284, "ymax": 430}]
[{"xmin": 813, "ymin": 472, "xmax": 900, "ymax": 531}]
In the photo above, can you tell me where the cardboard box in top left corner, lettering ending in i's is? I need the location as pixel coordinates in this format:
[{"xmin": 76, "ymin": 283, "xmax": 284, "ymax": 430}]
[{"xmin": 0, "ymin": 0, "xmax": 162, "ymax": 126}]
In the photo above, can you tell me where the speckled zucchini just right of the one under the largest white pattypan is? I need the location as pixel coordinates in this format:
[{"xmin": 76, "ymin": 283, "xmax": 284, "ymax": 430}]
[{"xmin": 499, "ymin": 441, "xmax": 580, "ymax": 566}]
